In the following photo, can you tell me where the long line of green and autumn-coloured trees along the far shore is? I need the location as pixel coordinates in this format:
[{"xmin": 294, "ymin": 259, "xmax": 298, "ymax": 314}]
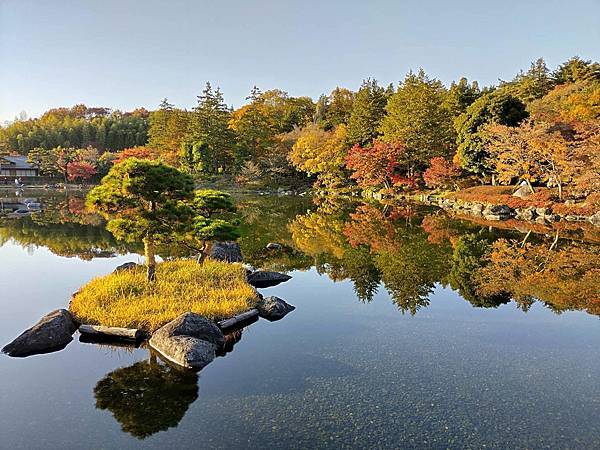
[{"xmin": 0, "ymin": 57, "xmax": 600, "ymax": 196}]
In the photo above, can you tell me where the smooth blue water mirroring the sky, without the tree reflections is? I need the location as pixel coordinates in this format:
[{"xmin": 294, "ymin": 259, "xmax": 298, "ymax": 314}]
[{"xmin": 0, "ymin": 243, "xmax": 600, "ymax": 448}]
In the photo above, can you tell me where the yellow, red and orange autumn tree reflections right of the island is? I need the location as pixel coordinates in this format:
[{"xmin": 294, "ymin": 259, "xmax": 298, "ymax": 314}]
[{"xmin": 290, "ymin": 200, "xmax": 600, "ymax": 314}]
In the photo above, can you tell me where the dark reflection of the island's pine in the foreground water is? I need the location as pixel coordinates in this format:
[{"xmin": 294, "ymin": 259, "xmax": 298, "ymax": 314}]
[{"xmin": 94, "ymin": 360, "xmax": 198, "ymax": 439}]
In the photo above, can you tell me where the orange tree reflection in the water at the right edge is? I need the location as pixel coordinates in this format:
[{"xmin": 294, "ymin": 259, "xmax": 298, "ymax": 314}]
[{"xmin": 476, "ymin": 239, "xmax": 600, "ymax": 314}]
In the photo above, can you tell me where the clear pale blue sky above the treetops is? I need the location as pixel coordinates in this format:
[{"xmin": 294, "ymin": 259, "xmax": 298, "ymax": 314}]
[{"xmin": 0, "ymin": 0, "xmax": 600, "ymax": 120}]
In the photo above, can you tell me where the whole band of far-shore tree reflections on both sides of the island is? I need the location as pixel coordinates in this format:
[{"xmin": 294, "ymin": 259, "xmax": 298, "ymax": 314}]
[{"xmin": 0, "ymin": 192, "xmax": 600, "ymax": 315}]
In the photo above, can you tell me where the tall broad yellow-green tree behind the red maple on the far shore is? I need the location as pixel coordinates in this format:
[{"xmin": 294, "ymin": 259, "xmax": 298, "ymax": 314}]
[{"xmin": 380, "ymin": 69, "xmax": 455, "ymax": 177}]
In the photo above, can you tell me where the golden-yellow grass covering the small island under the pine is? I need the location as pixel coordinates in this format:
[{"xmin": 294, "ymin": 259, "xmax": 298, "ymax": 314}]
[{"xmin": 69, "ymin": 259, "xmax": 257, "ymax": 331}]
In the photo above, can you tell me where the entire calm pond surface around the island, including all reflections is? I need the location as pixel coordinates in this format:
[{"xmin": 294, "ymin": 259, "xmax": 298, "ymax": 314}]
[{"xmin": 0, "ymin": 188, "xmax": 600, "ymax": 449}]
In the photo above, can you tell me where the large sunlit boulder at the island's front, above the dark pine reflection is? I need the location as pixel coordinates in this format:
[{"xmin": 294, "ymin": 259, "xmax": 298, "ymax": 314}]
[{"xmin": 150, "ymin": 312, "xmax": 225, "ymax": 370}]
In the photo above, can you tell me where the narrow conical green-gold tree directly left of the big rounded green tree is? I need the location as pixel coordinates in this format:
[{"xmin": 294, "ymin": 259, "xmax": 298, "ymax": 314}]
[{"xmin": 346, "ymin": 79, "xmax": 387, "ymax": 145}]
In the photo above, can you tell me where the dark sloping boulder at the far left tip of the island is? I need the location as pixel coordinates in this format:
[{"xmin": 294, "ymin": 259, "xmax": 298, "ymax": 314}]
[{"xmin": 2, "ymin": 309, "xmax": 77, "ymax": 356}]
